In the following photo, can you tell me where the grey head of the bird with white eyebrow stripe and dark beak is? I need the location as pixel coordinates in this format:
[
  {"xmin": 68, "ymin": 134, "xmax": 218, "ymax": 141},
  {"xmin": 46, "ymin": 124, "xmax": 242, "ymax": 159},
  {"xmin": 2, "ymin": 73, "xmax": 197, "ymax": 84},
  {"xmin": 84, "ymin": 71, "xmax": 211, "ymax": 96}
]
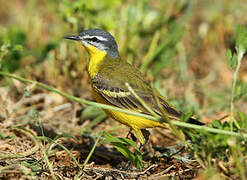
[{"xmin": 64, "ymin": 29, "xmax": 119, "ymax": 58}]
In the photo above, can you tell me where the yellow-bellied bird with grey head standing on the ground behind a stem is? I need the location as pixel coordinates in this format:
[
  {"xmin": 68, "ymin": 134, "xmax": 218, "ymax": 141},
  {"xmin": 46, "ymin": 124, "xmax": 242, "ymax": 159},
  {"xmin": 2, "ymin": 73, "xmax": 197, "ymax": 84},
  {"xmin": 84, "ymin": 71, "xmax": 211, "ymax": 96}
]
[{"xmin": 64, "ymin": 29, "xmax": 204, "ymax": 145}]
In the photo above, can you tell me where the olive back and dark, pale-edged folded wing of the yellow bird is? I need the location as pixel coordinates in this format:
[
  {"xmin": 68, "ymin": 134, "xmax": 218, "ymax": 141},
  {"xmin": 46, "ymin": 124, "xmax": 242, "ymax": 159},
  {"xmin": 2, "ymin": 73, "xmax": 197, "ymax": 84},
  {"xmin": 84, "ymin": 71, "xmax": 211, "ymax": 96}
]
[{"xmin": 92, "ymin": 59, "xmax": 181, "ymax": 118}]
